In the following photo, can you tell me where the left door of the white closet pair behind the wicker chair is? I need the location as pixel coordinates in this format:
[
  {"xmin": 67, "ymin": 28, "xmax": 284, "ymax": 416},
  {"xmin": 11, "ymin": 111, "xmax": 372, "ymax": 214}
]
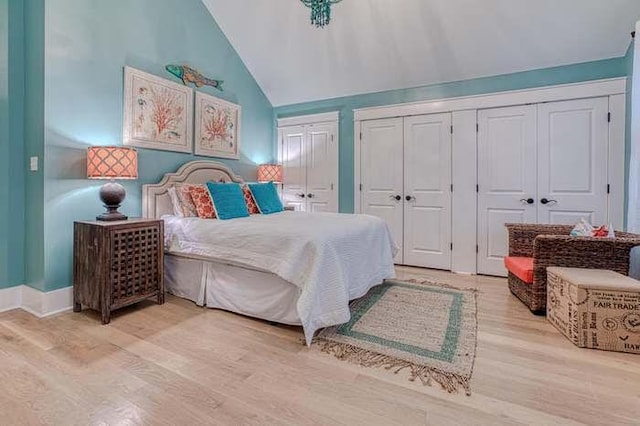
[{"xmin": 478, "ymin": 105, "xmax": 537, "ymax": 276}]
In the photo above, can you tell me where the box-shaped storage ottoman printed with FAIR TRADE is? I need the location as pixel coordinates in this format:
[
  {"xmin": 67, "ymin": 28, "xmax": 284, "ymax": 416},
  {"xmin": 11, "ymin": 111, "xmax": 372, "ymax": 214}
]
[{"xmin": 547, "ymin": 267, "xmax": 640, "ymax": 354}]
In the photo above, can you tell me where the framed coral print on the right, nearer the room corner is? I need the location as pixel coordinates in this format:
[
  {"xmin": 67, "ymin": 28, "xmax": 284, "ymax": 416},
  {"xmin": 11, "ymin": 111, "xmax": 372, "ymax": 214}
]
[{"xmin": 195, "ymin": 92, "xmax": 242, "ymax": 159}]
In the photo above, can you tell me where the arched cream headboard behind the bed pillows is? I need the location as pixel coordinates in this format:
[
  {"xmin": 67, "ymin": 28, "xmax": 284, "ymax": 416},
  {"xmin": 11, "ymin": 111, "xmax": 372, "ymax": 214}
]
[{"xmin": 142, "ymin": 161, "xmax": 244, "ymax": 219}]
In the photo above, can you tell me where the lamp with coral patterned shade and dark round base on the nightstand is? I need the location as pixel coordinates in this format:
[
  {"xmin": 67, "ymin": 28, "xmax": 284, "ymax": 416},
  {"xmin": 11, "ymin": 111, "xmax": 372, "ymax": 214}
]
[{"xmin": 87, "ymin": 146, "xmax": 138, "ymax": 221}]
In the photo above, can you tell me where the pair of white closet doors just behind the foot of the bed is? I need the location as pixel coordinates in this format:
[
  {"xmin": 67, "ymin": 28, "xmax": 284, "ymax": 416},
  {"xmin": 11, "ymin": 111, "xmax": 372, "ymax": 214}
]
[{"xmin": 360, "ymin": 114, "xmax": 451, "ymax": 269}]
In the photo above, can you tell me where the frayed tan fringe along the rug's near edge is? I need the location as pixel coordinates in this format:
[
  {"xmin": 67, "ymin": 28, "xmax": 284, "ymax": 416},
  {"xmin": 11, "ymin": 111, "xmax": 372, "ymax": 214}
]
[{"xmin": 312, "ymin": 337, "xmax": 471, "ymax": 396}]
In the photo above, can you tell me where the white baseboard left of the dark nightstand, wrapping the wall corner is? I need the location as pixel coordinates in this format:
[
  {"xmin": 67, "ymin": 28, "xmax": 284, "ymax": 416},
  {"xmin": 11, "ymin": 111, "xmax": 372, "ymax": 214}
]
[{"xmin": 0, "ymin": 285, "xmax": 73, "ymax": 318}]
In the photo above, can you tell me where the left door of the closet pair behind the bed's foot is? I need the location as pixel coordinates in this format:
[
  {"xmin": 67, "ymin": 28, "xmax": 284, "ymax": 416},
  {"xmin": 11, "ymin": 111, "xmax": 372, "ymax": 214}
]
[{"xmin": 360, "ymin": 118, "xmax": 404, "ymax": 263}]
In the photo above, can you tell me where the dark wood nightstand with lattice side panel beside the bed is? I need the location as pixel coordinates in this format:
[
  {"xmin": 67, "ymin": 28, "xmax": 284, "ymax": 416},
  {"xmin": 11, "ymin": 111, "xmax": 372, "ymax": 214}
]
[{"xmin": 73, "ymin": 219, "xmax": 164, "ymax": 324}]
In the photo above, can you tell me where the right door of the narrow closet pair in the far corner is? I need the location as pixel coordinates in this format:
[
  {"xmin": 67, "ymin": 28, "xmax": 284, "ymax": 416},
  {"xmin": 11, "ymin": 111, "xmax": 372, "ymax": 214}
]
[{"xmin": 305, "ymin": 123, "xmax": 338, "ymax": 212}]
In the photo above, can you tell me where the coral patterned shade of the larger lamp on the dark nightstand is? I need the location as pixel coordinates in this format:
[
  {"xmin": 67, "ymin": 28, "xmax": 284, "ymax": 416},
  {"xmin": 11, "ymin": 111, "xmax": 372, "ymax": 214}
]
[{"xmin": 87, "ymin": 146, "xmax": 138, "ymax": 179}]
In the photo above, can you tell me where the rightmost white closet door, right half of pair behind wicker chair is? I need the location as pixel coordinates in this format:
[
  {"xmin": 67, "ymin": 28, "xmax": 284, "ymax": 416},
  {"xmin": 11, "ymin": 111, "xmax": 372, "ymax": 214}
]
[{"xmin": 537, "ymin": 97, "xmax": 609, "ymax": 225}]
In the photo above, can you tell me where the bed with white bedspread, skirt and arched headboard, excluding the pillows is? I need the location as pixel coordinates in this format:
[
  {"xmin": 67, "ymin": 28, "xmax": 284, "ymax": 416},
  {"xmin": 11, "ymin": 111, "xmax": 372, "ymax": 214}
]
[{"xmin": 142, "ymin": 161, "xmax": 397, "ymax": 344}]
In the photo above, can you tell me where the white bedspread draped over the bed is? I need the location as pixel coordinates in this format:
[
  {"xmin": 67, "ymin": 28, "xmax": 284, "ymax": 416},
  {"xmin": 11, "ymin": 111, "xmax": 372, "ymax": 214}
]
[{"xmin": 164, "ymin": 212, "xmax": 398, "ymax": 344}]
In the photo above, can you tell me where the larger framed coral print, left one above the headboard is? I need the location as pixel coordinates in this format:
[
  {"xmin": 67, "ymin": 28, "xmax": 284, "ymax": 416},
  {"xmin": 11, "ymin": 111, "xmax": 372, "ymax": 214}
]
[{"xmin": 123, "ymin": 67, "xmax": 193, "ymax": 153}]
